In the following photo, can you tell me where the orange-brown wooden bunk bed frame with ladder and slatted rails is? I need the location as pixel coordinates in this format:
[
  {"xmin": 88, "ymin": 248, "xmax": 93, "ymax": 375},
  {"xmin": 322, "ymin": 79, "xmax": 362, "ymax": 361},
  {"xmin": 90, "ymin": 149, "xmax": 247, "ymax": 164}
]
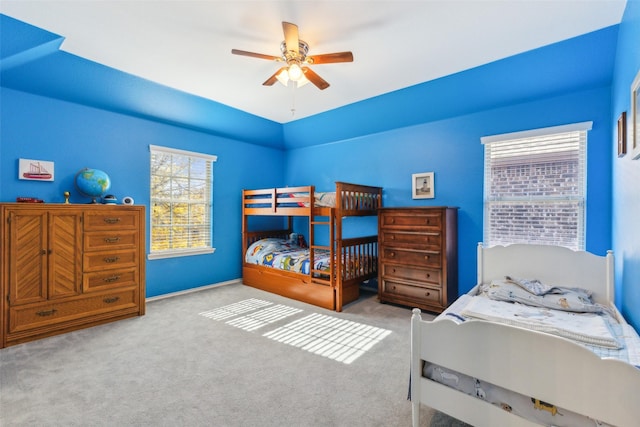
[{"xmin": 242, "ymin": 182, "xmax": 382, "ymax": 311}]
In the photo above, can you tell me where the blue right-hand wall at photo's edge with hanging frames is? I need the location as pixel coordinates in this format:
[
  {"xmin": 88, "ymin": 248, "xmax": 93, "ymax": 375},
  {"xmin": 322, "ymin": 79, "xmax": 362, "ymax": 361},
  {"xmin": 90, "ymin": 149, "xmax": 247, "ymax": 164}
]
[{"xmin": 610, "ymin": 0, "xmax": 640, "ymax": 330}]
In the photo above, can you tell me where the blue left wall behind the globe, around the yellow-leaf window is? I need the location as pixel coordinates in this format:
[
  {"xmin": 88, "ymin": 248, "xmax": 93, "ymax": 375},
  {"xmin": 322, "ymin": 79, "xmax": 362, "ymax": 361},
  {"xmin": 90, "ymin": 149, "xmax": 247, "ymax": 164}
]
[{"xmin": 0, "ymin": 88, "xmax": 284, "ymax": 297}]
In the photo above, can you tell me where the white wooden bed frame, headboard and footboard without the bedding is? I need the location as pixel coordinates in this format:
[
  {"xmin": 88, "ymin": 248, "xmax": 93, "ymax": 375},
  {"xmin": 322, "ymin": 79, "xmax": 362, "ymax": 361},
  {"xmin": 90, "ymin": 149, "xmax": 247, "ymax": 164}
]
[{"xmin": 411, "ymin": 244, "xmax": 640, "ymax": 427}]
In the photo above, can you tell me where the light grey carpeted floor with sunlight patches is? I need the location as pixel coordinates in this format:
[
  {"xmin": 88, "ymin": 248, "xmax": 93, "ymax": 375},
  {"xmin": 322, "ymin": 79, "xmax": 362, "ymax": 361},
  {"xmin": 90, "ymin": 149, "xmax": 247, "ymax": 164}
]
[{"xmin": 0, "ymin": 283, "xmax": 452, "ymax": 427}]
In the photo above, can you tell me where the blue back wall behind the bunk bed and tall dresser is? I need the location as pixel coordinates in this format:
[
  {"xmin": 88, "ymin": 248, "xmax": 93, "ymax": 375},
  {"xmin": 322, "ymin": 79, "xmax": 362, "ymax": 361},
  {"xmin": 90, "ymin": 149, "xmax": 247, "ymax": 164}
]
[{"xmin": 286, "ymin": 85, "xmax": 611, "ymax": 292}]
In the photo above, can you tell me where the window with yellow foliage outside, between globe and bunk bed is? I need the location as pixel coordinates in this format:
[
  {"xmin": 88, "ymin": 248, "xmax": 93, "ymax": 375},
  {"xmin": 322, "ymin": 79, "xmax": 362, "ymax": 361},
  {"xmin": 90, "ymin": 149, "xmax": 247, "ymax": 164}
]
[{"xmin": 149, "ymin": 145, "xmax": 216, "ymax": 259}]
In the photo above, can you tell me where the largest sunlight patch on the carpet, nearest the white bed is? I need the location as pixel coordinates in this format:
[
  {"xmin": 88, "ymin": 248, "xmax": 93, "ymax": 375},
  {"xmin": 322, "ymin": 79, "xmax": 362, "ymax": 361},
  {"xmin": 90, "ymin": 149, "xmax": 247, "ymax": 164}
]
[{"xmin": 263, "ymin": 314, "xmax": 391, "ymax": 364}]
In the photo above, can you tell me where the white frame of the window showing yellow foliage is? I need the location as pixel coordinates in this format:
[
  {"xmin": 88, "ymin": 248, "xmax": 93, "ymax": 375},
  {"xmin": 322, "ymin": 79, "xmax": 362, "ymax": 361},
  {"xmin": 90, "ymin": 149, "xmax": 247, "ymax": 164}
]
[{"xmin": 147, "ymin": 145, "xmax": 218, "ymax": 260}]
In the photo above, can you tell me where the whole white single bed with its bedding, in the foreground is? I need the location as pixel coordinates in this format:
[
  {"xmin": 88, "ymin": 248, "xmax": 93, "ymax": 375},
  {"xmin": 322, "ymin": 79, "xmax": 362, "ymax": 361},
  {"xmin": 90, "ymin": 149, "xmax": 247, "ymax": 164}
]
[{"xmin": 410, "ymin": 245, "xmax": 640, "ymax": 427}]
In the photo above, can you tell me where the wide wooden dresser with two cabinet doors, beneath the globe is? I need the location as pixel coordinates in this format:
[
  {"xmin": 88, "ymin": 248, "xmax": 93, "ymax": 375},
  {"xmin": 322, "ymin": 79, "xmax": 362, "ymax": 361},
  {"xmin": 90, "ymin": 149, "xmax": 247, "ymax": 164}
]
[{"xmin": 0, "ymin": 203, "xmax": 145, "ymax": 348}]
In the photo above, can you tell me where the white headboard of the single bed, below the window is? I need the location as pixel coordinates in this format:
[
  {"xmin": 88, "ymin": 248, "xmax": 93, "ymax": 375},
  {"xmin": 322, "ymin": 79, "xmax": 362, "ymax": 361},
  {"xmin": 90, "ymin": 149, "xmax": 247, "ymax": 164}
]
[{"xmin": 478, "ymin": 243, "xmax": 615, "ymax": 305}]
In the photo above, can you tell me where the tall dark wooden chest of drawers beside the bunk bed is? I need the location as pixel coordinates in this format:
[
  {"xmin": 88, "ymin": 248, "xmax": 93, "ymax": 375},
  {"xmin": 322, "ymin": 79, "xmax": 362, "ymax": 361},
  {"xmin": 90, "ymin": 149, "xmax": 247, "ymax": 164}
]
[{"xmin": 378, "ymin": 207, "xmax": 458, "ymax": 313}]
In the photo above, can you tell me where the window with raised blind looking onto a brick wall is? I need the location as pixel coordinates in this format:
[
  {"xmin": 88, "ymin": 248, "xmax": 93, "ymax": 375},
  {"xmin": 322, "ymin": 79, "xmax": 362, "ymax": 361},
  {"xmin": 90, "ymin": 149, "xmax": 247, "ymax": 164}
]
[{"xmin": 482, "ymin": 122, "xmax": 591, "ymax": 250}]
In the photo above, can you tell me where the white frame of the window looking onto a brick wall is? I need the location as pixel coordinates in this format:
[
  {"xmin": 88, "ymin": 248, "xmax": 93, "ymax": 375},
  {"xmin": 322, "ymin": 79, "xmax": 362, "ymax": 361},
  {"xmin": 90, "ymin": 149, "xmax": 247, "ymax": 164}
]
[{"xmin": 481, "ymin": 122, "xmax": 593, "ymax": 251}]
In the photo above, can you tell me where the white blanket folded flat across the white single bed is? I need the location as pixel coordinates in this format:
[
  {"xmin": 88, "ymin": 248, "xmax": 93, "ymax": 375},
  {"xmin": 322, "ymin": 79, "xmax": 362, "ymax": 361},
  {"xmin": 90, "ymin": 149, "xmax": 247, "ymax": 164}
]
[{"xmin": 460, "ymin": 298, "xmax": 621, "ymax": 349}]
